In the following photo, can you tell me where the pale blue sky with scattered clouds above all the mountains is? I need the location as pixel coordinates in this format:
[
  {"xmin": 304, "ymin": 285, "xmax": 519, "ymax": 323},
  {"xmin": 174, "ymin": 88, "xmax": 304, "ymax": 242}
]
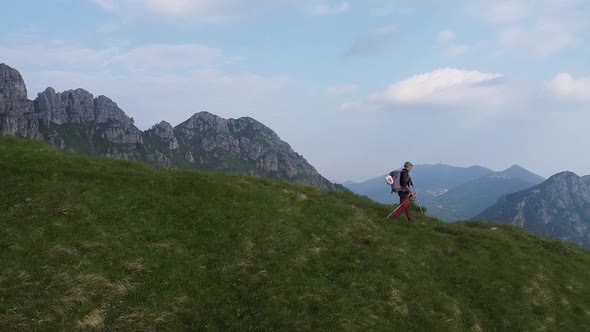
[{"xmin": 0, "ymin": 0, "xmax": 590, "ymax": 182}]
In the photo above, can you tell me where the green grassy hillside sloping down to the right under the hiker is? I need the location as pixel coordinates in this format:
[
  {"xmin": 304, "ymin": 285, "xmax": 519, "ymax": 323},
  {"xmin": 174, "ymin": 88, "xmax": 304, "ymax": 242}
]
[{"xmin": 0, "ymin": 138, "xmax": 590, "ymax": 331}]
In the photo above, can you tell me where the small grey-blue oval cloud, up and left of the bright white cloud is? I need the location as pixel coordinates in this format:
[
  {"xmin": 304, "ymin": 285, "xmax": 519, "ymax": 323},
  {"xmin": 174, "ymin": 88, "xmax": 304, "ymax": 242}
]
[{"xmin": 346, "ymin": 26, "xmax": 399, "ymax": 56}]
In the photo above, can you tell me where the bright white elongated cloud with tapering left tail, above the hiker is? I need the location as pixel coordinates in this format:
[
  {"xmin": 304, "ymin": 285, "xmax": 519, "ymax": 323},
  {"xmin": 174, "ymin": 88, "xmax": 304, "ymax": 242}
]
[{"xmin": 340, "ymin": 68, "xmax": 512, "ymax": 119}]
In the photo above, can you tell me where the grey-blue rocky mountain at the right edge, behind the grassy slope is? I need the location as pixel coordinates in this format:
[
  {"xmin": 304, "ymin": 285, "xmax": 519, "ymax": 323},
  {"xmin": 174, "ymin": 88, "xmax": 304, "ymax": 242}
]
[{"xmin": 474, "ymin": 172, "xmax": 590, "ymax": 249}]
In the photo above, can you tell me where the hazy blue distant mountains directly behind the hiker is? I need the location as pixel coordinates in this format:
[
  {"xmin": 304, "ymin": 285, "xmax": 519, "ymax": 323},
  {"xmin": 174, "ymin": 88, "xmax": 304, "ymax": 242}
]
[{"xmin": 345, "ymin": 164, "xmax": 544, "ymax": 221}]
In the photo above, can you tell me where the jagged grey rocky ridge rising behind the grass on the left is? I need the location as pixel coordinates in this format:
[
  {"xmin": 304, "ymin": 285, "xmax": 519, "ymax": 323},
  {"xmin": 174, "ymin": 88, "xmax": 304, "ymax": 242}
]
[{"xmin": 0, "ymin": 64, "xmax": 345, "ymax": 190}]
